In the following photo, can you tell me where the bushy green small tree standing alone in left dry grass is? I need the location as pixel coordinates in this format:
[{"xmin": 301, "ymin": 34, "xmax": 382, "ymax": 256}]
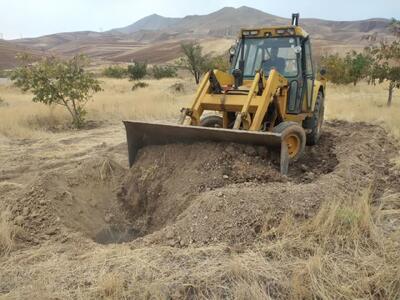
[{"xmin": 10, "ymin": 55, "xmax": 101, "ymax": 128}]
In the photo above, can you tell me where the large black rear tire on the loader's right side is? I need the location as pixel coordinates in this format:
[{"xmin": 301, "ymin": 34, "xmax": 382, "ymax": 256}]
[{"xmin": 303, "ymin": 92, "xmax": 325, "ymax": 146}]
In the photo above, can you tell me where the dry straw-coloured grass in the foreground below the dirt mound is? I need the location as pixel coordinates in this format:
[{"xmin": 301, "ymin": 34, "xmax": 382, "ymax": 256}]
[{"xmin": 3, "ymin": 191, "xmax": 400, "ymax": 300}]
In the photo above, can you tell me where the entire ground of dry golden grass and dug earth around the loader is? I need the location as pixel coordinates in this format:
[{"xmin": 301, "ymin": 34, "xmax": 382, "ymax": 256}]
[{"xmin": 0, "ymin": 78, "xmax": 400, "ymax": 300}]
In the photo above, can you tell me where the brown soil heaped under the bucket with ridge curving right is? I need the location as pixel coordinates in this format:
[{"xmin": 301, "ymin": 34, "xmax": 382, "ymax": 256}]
[{"xmin": 115, "ymin": 122, "xmax": 394, "ymax": 247}]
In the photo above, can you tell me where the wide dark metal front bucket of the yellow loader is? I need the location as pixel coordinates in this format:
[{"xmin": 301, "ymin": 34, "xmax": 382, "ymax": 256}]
[{"xmin": 124, "ymin": 121, "xmax": 289, "ymax": 175}]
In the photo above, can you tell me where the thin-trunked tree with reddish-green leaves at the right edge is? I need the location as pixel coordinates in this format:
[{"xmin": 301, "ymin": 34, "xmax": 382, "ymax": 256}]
[{"xmin": 369, "ymin": 41, "xmax": 400, "ymax": 106}]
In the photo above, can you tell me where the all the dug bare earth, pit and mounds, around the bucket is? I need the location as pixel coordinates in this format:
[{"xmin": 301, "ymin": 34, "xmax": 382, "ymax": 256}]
[{"xmin": 3, "ymin": 122, "xmax": 395, "ymax": 247}]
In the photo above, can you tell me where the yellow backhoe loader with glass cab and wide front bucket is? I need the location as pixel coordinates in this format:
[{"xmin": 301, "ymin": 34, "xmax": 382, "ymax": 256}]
[{"xmin": 124, "ymin": 14, "xmax": 326, "ymax": 174}]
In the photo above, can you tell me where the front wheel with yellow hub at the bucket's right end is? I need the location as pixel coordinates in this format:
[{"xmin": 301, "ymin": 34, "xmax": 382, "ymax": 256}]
[{"xmin": 272, "ymin": 122, "xmax": 306, "ymax": 162}]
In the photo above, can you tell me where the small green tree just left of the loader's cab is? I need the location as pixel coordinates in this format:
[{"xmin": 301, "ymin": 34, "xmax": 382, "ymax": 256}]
[{"xmin": 179, "ymin": 43, "xmax": 206, "ymax": 84}]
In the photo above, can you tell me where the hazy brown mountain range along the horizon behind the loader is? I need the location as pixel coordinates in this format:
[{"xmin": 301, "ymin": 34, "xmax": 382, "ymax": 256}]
[{"xmin": 0, "ymin": 6, "xmax": 392, "ymax": 67}]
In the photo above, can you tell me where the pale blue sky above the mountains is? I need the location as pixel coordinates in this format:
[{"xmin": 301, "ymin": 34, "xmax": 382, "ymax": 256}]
[{"xmin": 0, "ymin": 0, "xmax": 400, "ymax": 39}]
